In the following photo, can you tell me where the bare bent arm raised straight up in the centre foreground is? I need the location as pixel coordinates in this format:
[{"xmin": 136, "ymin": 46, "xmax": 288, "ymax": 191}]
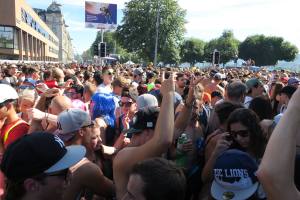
[{"xmin": 113, "ymin": 72, "xmax": 175, "ymax": 199}]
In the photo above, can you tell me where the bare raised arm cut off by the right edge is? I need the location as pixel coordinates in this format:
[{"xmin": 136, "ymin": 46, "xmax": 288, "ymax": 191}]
[{"xmin": 257, "ymin": 89, "xmax": 300, "ymax": 200}]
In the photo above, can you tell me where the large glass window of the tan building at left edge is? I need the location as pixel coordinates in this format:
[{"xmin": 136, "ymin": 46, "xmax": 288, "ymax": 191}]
[{"xmin": 0, "ymin": 26, "xmax": 14, "ymax": 49}]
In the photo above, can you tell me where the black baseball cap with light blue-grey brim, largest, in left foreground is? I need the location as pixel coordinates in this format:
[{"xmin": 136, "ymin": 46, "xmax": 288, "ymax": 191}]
[{"xmin": 1, "ymin": 132, "xmax": 86, "ymax": 181}]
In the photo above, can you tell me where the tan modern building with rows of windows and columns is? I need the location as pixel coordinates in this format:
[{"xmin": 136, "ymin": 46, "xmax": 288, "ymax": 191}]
[{"xmin": 0, "ymin": 0, "xmax": 59, "ymax": 61}]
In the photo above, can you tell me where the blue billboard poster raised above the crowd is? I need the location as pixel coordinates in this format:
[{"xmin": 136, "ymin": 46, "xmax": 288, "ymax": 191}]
[{"xmin": 85, "ymin": 1, "xmax": 117, "ymax": 29}]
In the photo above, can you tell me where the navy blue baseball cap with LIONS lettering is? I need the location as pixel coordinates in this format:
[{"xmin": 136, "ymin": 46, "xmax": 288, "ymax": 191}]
[{"xmin": 211, "ymin": 149, "xmax": 259, "ymax": 200}]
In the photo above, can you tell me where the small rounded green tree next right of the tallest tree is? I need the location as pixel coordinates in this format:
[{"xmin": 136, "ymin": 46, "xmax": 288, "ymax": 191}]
[{"xmin": 180, "ymin": 38, "xmax": 205, "ymax": 65}]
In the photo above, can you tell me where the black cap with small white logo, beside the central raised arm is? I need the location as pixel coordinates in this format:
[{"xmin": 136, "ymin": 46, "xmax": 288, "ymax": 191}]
[{"xmin": 126, "ymin": 107, "xmax": 159, "ymax": 135}]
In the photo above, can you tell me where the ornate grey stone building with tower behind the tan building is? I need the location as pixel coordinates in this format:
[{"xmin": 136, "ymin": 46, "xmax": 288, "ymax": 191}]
[{"xmin": 35, "ymin": 1, "xmax": 74, "ymax": 63}]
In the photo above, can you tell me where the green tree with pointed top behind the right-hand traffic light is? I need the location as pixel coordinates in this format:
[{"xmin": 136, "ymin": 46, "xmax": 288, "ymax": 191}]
[{"xmin": 204, "ymin": 30, "xmax": 240, "ymax": 63}]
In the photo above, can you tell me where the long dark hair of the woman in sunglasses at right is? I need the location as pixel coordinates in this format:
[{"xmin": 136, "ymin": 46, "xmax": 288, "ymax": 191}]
[{"xmin": 227, "ymin": 108, "xmax": 266, "ymax": 159}]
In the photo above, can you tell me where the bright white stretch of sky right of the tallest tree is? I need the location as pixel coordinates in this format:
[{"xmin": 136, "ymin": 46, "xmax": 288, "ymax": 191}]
[{"xmin": 179, "ymin": 0, "xmax": 300, "ymax": 48}]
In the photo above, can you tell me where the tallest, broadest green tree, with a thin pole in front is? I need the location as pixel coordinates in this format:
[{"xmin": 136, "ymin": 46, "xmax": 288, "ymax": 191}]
[{"xmin": 117, "ymin": 0, "xmax": 186, "ymax": 63}]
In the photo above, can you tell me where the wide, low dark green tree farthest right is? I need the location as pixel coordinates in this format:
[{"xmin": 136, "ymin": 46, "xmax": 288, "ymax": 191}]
[{"xmin": 239, "ymin": 35, "xmax": 298, "ymax": 66}]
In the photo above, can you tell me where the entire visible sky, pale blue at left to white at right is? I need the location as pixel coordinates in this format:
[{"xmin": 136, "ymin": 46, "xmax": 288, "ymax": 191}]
[{"xmin": 26, "ymin": 0, "xmax": 300, "ymax": 53}]
